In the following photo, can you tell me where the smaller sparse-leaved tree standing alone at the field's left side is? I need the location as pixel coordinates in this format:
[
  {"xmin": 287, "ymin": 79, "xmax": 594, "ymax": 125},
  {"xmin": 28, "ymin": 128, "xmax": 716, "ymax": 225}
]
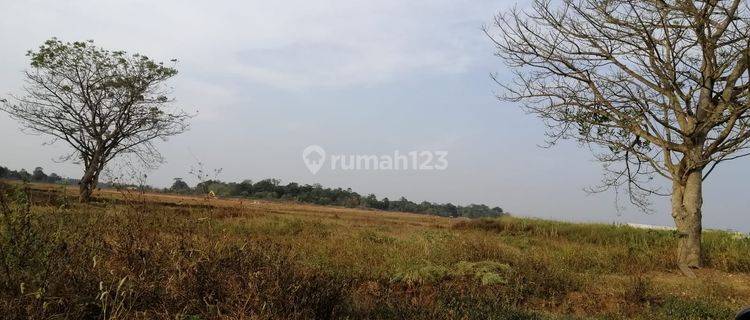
[{"xmin": 2, "ymin": 38, "xmax": 191, "ymax": 202}]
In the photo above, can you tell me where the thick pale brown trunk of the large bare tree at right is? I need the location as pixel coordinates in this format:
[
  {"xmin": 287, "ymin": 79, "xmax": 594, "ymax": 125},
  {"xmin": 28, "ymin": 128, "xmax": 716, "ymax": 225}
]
[{"xmin": 672, "ymin": 170, "xmax": 703, "ymax": 268}]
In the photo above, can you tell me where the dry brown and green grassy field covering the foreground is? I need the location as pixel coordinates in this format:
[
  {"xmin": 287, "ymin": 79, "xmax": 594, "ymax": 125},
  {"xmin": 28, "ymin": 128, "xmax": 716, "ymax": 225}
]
[{"xmin": 0, "ymin": 184, "xmax": 750, "ymax": 319}]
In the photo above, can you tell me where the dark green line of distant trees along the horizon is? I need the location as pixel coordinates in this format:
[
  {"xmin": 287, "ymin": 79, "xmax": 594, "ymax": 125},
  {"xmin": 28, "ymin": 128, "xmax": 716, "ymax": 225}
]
[{"xmin": 0, "ymin": 166, "xmax": 505, "ymax": 218}]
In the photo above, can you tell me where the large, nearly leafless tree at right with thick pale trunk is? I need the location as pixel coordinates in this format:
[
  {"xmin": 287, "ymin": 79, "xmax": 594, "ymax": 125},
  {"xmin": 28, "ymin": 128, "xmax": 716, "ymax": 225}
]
[{"xmin": 485, "ymin": 0, "xmax": 750, "ymax": 268}]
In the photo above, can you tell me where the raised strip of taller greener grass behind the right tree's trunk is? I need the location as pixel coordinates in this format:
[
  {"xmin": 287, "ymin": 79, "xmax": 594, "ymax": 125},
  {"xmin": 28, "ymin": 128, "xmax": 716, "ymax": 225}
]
[{"xmin": 454, "ymin": 217, "xmax": 750, "ymax": 273}]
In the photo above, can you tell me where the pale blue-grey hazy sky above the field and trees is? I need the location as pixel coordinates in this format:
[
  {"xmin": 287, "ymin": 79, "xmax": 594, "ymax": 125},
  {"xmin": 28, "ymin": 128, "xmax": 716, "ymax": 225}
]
[{"xmin": 0, "ymin": 0, "xmax": 750, "ymax": 232}]
